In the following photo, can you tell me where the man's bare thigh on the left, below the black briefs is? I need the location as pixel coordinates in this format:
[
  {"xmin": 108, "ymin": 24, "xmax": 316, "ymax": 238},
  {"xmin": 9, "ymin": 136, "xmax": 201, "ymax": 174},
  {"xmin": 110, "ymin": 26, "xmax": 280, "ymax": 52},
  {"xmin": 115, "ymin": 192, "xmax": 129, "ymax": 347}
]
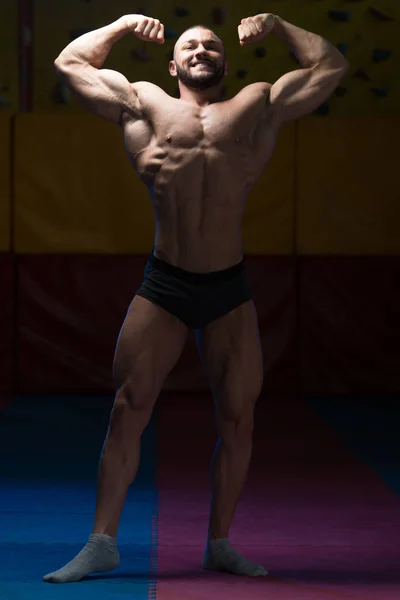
[{"xmin": 113, "ymin": 296, "xmax": 187, "ymax": 405}]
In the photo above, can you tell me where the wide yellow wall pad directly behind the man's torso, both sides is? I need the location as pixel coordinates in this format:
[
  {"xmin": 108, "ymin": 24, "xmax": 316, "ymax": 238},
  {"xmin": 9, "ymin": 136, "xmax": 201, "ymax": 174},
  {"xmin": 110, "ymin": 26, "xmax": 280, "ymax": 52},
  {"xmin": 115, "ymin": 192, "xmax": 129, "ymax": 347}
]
[{"xmin": 15, "ymin": 115, "xmax": 295, "ymax": 254}]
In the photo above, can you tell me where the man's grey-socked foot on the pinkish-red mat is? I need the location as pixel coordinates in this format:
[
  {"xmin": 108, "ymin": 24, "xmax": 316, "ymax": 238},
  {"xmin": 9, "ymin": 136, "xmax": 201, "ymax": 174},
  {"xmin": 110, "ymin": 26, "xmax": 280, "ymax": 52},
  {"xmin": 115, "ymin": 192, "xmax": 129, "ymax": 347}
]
[{"xmin": 201, "ymin": 538, "xmax": 268, "ymax": 577}]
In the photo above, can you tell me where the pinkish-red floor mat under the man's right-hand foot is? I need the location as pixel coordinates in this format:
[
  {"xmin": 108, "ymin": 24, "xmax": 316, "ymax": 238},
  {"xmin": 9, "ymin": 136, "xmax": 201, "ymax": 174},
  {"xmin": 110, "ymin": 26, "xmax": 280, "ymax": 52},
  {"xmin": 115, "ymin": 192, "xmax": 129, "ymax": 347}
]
[{"xmin": 157, "ymin": 396, "xmax": 400, "ymax": 600}]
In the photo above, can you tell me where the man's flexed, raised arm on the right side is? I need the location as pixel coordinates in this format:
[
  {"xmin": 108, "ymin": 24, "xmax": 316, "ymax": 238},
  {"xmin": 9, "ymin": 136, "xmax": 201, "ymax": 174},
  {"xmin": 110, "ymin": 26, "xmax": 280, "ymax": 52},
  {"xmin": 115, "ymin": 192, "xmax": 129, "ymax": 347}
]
[{"xmin": 238, "ymin": 14, "xmax": 349, "ymax": 123}]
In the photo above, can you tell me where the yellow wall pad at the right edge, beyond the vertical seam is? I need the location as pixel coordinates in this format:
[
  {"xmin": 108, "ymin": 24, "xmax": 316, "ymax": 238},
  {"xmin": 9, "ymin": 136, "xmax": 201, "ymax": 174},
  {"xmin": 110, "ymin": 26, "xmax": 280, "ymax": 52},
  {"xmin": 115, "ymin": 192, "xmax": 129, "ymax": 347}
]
[{"xmin": 296, "ymin": 117, "xmax": 400, "ymax": 255}]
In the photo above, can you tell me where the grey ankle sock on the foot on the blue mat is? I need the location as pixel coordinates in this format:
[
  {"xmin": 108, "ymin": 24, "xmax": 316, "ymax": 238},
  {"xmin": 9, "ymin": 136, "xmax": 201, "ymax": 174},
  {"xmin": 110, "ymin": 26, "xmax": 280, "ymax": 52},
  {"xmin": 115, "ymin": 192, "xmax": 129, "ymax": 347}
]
[{"xmin": 43, "ymin": 533, "xmax": 119, "ymax": 583}]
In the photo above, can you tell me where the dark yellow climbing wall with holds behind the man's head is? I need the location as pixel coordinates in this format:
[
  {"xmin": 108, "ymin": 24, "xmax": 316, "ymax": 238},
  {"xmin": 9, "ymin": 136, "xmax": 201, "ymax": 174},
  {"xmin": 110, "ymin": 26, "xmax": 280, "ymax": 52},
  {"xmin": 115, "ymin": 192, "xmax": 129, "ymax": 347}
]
[{"xmin": 34, "ymin": 0, "xmax": 400, "ymax": 115}]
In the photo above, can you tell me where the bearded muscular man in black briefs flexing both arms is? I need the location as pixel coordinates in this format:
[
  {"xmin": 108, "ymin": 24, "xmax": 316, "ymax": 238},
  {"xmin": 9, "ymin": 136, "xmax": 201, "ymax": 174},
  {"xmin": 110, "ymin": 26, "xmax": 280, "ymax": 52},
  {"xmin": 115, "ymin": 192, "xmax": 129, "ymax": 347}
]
[{"xmin": 44, "ymin": 14, "xmax": 348, "ymax": 582}]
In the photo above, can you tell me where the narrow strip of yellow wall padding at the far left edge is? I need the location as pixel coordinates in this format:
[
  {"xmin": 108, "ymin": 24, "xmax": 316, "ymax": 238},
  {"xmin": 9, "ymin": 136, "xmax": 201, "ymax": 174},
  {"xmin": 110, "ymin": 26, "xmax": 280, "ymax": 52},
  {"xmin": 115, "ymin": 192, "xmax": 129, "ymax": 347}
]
[{"xmin": 0, "ymin": 114, "xmax": 11, "ymax": 252}]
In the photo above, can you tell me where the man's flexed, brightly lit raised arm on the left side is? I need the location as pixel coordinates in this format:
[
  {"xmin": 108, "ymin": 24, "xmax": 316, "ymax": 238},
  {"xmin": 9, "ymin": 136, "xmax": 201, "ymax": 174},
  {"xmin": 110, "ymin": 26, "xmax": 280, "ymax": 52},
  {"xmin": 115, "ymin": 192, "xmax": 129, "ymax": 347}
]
[{"xmin": 54, "ymin": 15, "xmax": 163, "ymax": 123}]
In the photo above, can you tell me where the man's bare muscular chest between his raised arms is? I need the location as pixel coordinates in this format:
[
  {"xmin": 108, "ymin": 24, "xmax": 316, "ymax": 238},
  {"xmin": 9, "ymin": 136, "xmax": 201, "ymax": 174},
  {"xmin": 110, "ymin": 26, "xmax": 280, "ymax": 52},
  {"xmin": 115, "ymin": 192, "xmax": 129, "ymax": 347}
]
[{"xmin": 125, "ymin": 96, "xmax": 273, "ymax": 172}]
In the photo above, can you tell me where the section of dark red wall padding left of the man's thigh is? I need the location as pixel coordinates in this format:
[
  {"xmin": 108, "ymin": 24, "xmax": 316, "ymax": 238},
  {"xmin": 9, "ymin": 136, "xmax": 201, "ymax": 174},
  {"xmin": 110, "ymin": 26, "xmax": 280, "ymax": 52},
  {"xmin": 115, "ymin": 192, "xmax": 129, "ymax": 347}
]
[{"xmin": 18, "ymin": 255, "xmax": 145, "ymax": 392}]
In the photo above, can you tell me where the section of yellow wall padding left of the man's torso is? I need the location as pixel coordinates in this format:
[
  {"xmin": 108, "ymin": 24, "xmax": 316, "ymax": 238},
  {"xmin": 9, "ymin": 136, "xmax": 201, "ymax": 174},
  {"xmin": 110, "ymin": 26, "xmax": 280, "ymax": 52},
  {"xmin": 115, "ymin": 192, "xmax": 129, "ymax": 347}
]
[{"xmin": 15, "ymin": 114, "xmax": 154, "ymax": 254}]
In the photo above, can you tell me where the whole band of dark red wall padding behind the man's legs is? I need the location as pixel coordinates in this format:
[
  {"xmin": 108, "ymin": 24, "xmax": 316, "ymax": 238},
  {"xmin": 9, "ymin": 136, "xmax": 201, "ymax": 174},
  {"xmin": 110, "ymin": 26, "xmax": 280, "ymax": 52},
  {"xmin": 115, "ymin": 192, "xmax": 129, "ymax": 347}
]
[{"xmin": 14, "ymin": 255, "xmax": 400, "ymax": 395}]
